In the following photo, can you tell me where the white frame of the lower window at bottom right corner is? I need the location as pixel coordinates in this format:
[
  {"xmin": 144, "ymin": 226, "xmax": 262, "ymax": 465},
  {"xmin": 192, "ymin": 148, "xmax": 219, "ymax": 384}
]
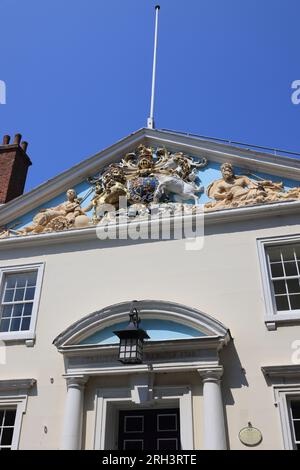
[{"xmin": 274, "ymin": 385, "xmax": 300, "ymax": 450}]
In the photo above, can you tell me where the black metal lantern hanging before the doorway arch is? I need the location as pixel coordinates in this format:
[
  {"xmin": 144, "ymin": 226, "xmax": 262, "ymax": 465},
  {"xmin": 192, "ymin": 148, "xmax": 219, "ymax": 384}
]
[{"xmin": 114, "ymin": 300, "xmax": 149, "ymax": 364}]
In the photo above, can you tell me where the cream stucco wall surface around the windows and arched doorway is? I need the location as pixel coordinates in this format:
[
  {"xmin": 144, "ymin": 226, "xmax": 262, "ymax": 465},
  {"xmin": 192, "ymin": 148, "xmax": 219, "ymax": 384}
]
[{"xmin": 0, "ymin": 212, "xmax": 300, "ymax": 449}]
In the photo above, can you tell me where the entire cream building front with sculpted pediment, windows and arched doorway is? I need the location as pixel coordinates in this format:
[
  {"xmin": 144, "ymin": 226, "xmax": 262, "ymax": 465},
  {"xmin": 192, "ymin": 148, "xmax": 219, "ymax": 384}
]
[{"xmin": 0, "ymin": 129, "xmax": 300, "ymax": 451}]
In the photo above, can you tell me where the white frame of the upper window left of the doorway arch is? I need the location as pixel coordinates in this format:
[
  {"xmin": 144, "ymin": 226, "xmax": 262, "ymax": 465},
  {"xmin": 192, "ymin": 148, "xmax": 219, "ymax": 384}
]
[{"xmin": 0, "ymin": 263, "xmax": 45, "ymax": 346}]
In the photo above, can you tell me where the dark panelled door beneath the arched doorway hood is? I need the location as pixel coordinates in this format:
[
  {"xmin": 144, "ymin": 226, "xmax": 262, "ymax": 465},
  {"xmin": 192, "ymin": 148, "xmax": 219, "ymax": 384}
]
[{"xmin": 118, "ymin": 408, "xmax": 180, "ymax": 450}]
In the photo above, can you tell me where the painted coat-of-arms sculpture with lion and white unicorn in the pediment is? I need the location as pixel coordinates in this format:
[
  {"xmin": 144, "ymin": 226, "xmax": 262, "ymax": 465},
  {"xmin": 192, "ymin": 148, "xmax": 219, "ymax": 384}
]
[{"xmin": 84, "ymin": 145, "xmax": 207, "ymax": 223}]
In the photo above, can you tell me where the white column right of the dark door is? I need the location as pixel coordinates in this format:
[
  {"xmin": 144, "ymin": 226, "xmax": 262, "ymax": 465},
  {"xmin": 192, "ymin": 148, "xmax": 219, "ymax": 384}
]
[{"xmin": 198, "ymin": 367, "xmax": 227, "ymax": 450}]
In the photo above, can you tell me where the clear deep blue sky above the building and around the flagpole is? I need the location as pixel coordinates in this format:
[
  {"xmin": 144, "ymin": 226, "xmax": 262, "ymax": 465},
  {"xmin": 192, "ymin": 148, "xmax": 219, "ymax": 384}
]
[{"xmin": 0, "ymin": 0, "xmax": 300, "ymax": 190}]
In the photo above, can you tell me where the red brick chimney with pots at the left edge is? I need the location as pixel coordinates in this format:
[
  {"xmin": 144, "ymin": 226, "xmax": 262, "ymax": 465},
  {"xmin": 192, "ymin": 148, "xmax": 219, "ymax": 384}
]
[{"xmin": 0, "ymin": 134, "xmax": 31, "ymax": 204}]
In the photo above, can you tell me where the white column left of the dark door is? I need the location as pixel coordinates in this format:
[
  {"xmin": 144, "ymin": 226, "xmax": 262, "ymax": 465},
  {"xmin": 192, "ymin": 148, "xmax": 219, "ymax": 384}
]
[{"xmin": 62, "ymin": 375, "xmax": 88, "ymax": 450}]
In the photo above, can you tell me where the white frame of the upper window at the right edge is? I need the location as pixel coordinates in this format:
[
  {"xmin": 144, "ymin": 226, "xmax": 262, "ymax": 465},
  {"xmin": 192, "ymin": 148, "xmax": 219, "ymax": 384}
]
[{"xmin": 257, "ymin": 234, "xmax": 300, "ymax": 330}]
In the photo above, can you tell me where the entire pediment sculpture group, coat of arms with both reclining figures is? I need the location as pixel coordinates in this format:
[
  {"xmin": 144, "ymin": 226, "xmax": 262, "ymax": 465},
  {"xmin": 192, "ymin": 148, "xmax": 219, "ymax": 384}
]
[{"xmin": 0, "ymin": 145, "xmax": 300, "ymax": 238}]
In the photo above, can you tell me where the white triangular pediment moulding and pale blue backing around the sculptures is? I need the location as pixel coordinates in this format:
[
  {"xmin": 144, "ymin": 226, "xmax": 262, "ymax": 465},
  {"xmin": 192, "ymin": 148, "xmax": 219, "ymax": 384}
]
[{"xmin": 0, "ymin": 129, "xmax": 300, "ymax": 239}]
